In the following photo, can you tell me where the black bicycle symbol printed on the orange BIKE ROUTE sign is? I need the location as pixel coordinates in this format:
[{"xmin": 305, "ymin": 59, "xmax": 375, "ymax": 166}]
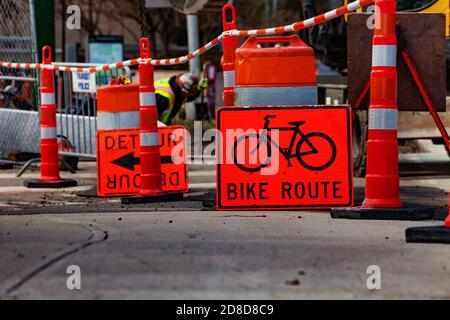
[{"xmin": 232, "ymin": 115, "xmax": 336, "ymax": 172}]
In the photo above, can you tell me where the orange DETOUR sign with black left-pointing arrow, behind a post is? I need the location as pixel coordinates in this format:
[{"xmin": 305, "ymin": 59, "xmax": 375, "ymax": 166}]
[{"xmin": 97, "ymin": 126, "xmax": 188, "ymax": 197}]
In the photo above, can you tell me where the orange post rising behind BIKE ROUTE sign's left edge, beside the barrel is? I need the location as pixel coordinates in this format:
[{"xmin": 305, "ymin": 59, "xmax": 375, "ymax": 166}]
[{"xmin": 222, "ymin": 4, "xmax": 239, "ymax": 107}]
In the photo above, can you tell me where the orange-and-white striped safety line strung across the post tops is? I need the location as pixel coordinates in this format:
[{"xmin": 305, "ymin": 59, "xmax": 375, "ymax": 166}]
[{"xmin": 0, "ymin": 0, "xmax": 374, "ymax": 73}]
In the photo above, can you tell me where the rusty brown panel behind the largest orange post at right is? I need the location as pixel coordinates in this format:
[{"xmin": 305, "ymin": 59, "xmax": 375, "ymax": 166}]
[{"xmin": 347, "ymin": 13, "xmax": 446, "ymax": 112}]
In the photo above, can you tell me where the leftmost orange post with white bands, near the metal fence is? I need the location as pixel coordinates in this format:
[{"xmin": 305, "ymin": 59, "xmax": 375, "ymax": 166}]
[{"xmin": 41, "ymin": 46, "xmax": 61, "ymax": 182}]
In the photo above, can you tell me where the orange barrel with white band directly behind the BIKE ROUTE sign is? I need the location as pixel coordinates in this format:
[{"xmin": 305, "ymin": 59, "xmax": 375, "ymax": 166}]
[{"xmin": 235, "ymin": 35, "xmax": 317, "ymax": 106}]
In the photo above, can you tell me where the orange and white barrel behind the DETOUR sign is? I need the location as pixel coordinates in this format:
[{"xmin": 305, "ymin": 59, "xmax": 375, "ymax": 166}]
[{"xmin": 97, "ymin": 83, "xmax": 140, "ymax": 130}]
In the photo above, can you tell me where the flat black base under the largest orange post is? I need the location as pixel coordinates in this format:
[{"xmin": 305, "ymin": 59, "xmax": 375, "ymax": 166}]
[{"xmin": 331, "ymin": 207, "xmax": 434, "ymax": 221}]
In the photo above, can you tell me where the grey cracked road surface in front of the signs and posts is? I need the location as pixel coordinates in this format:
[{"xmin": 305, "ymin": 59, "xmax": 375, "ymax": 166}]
[{"xmin": 0, "ymin": 145, "xmax": 450, "ymax": 299}]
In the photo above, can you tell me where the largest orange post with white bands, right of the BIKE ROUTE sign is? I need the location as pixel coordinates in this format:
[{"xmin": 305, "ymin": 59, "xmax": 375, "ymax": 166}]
[{"xmin": 363, "ymin": 0, "xmax": 402, "ymax": 208}]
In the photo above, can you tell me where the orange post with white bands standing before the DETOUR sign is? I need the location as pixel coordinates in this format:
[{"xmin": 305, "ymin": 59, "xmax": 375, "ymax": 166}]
[{"xmin": 139, "ymin": 38, "xmax": 162, "ymax": 196}]
